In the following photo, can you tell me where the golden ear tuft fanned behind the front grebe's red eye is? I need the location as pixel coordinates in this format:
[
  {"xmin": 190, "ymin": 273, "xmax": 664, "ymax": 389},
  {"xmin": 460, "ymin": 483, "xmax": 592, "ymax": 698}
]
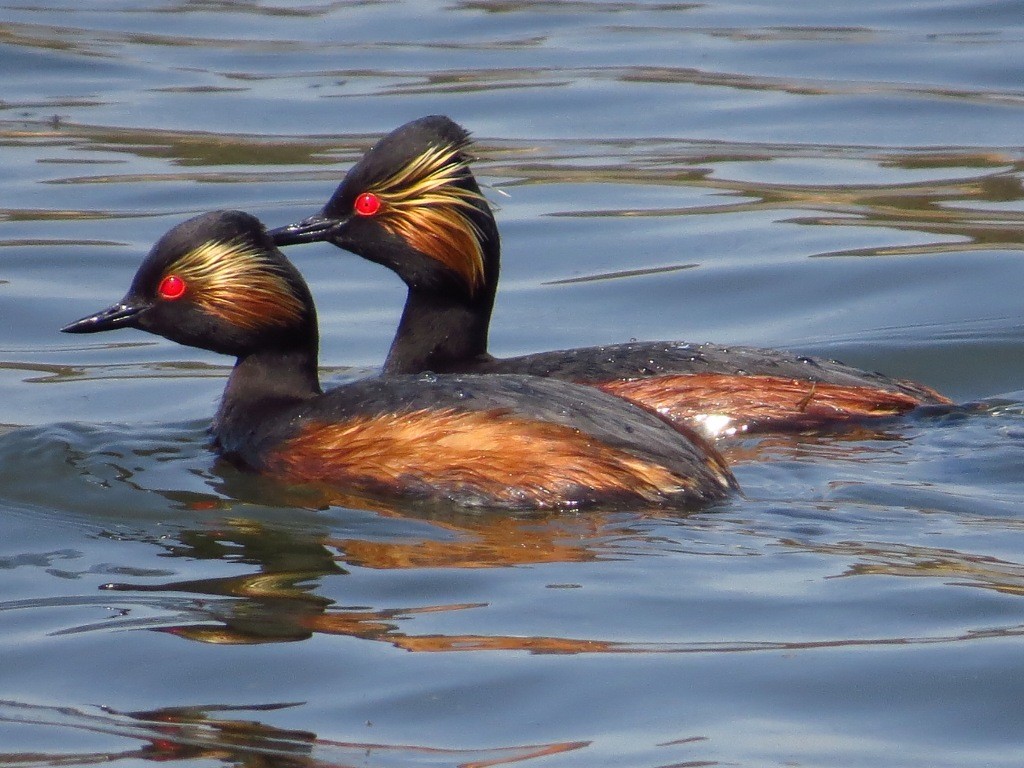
[{"xmin": 164, "ymin": 240, "xmax": 305, "ymax": 331}]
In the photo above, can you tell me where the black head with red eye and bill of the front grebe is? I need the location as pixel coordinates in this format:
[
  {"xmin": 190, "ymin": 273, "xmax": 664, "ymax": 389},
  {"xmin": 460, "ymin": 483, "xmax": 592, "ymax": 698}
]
[{"xmin": 60, "ymin": 211, "xmax": 316, "ymax": 356}]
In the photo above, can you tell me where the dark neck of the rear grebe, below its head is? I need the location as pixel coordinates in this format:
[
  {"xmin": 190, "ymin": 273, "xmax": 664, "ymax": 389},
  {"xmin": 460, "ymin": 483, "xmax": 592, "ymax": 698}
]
[{"xmin": 384, "ymin": 283, "xmax": 495, "ymax": 374}]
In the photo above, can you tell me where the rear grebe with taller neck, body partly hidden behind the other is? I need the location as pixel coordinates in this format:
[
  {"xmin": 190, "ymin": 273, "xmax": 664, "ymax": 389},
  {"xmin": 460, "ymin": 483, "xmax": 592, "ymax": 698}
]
[{"xmin": 270, "ymin": 115, "xmax": 950, "ymax": 436}]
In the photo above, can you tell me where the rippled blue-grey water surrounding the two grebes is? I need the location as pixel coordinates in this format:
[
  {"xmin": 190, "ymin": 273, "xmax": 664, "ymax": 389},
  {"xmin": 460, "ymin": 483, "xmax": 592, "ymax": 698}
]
[{"xmin": 0, "ymin": 0, "xmax": 1024, "ymax": 768}]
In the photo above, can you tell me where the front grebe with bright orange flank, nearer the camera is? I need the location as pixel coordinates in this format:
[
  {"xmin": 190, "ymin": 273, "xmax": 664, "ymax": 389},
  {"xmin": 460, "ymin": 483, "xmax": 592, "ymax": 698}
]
[{"xmin": 61, "ymin": 211, "xmax": 736, "ymax": 508}]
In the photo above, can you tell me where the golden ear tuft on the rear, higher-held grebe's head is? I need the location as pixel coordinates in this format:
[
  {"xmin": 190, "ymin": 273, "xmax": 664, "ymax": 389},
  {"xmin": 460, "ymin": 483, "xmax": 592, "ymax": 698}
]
[{"xmin": 367, "ymin": 143, "xmax": 483, "ymax": 294}]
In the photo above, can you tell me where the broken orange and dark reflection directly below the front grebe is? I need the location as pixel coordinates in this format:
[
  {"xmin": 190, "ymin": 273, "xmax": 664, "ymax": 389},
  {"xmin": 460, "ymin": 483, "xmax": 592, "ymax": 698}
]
[{"xmin": 103, "ymin": 473, "xmax": 679, "ymax": 652}]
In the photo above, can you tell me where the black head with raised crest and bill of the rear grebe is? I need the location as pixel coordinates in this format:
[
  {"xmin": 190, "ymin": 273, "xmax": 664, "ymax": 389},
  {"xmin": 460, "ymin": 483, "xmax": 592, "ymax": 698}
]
[{"xmin": 270, "ymin": 115, "xmax": 500, "ymax": 301}]
